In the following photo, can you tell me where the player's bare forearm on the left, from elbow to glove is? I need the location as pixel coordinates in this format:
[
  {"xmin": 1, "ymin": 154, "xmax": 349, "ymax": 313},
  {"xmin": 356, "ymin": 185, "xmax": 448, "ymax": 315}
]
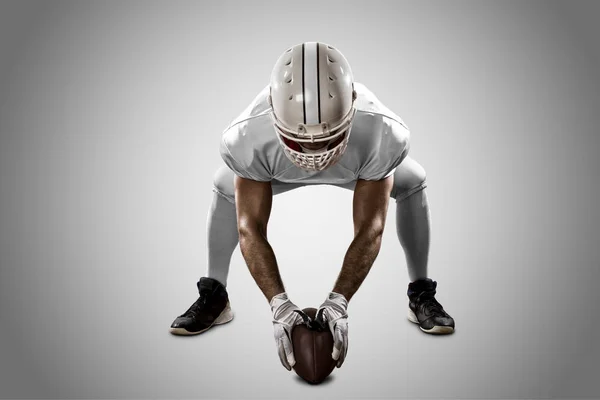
[{"xmin": 239, "ymin": 230, "xmax": 285, "ymax": 302}]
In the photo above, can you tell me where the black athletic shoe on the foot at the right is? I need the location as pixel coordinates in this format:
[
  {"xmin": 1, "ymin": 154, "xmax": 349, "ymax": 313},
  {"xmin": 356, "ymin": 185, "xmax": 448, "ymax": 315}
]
[{"xmin": 407, "ymin": 278, "xmax": 454, "ymax": 335}]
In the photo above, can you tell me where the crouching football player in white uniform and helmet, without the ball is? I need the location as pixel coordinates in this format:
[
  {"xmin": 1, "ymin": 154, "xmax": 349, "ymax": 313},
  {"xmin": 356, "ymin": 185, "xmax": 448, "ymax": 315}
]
[{"xmin": 170, "ymin": 42, "xmax": 455, "ymax": 370}]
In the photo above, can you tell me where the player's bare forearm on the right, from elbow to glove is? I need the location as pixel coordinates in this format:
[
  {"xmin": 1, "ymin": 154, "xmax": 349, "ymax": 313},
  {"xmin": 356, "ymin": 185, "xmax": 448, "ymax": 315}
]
[{"xmin": 333, "ymin": 233, "xmax": 382, "ymax": 301}]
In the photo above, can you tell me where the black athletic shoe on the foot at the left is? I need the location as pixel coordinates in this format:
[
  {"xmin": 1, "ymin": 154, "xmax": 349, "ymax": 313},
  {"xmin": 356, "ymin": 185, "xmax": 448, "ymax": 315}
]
[{"xmin": 169, "ymin": 278, "xmax": 233, "ymax": 336}]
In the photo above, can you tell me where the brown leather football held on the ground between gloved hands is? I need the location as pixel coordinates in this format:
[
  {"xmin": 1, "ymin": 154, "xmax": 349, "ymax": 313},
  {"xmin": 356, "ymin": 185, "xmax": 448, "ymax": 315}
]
[{"xmin": 292, "ymin": 308, "xmax": 336, "ymax": 384}]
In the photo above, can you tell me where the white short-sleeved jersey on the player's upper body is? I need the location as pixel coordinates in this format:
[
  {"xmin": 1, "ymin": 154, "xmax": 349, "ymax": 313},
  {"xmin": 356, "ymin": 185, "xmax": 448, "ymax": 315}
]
[{"xmin": 220, "ymin": 82, "xmax": 410, "ymax": 184}]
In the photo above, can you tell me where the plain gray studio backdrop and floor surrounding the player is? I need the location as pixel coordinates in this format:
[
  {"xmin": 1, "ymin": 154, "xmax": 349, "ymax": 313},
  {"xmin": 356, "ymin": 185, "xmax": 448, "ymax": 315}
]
[{"xmin": 0, "ymin": 1, "xmax": 600, "ymax": 399}]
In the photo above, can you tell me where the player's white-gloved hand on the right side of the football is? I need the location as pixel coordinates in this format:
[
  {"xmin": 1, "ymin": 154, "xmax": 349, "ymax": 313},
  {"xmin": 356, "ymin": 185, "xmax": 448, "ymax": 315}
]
[{"xmin": 317, "ymin": 292, "xmax": 348, "ymax": 368}]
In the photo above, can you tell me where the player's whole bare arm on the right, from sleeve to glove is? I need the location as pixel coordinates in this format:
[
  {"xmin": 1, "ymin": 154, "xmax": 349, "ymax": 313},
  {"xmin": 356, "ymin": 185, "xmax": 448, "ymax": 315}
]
[{"xmin": 333, "ymin": 175, "xmax": 394, "ymax": 301}]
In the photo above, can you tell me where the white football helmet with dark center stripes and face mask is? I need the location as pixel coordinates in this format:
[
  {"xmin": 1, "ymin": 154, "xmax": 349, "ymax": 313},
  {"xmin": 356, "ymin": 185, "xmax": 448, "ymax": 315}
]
[{"xmin": 269, "ymin": 42, "xmax": 356, "ymax": 171}]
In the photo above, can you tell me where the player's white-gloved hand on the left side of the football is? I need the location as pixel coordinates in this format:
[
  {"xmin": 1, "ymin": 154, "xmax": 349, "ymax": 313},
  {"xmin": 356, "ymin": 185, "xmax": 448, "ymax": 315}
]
[{"xmin": 270, "ymin": 292, "xmax": 304, "ymax": 371}]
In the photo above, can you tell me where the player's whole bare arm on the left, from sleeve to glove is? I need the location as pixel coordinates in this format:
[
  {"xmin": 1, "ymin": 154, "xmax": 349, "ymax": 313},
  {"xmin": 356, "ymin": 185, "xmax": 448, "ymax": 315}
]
[{"xmin": 234, "ymin": 176, "xmax": 285, "ymax": 302}]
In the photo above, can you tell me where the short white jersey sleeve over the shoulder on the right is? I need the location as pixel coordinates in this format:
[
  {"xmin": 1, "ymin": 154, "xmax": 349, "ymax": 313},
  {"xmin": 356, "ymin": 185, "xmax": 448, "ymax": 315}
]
[{"xmin": 358, "ymin": 122, "xmax": 410, "ymax": 181}]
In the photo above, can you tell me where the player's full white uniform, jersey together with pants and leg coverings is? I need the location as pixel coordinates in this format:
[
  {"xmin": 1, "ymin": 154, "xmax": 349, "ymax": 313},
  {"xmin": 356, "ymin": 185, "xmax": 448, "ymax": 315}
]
[{"xmin": 207, "ymin": 82, "xmax": 429, "ymax": 290}]
